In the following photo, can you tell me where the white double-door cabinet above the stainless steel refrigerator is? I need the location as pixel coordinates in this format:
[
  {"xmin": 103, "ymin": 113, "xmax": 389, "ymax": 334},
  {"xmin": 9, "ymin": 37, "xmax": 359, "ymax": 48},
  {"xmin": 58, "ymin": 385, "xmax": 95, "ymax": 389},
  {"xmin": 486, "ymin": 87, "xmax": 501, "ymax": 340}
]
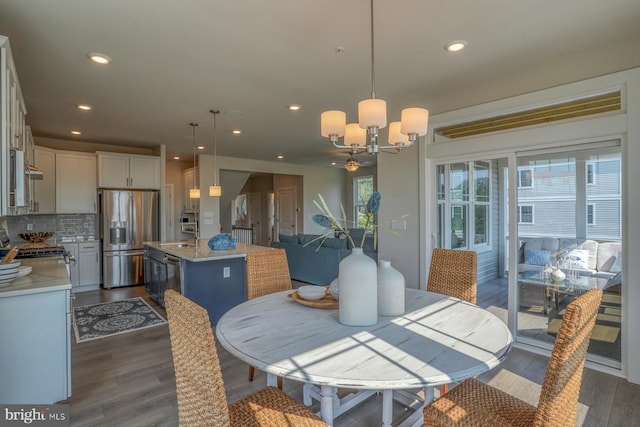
[{"xmin": 98, "ymin": 152, "xmax": 162, "ymax": 190}]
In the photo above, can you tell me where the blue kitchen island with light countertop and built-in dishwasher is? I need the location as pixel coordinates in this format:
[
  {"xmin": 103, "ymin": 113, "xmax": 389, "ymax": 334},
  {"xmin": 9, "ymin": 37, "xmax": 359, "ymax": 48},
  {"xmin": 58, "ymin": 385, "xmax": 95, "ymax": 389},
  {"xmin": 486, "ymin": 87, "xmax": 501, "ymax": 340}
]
[{"xmin": 144, "ymin": 239, "xmax": 273, "ymax": 325}]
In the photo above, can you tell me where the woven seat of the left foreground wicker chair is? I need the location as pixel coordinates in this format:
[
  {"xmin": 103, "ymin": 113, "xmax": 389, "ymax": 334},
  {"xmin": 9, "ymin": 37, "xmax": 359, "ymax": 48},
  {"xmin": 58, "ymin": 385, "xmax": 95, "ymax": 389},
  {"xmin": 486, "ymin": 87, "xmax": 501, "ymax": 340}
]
[{"xmin": 229, "ymin": 387, "xmax": 326, "ymax": 427}]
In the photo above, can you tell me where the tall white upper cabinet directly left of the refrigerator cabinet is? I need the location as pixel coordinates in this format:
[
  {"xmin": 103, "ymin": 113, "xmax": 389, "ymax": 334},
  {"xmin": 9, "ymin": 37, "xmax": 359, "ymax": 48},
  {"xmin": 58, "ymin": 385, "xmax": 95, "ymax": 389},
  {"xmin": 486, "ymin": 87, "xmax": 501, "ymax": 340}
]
[{"xmin": 56, "ymin": 151, "xmax": 97, "ymax": 213}]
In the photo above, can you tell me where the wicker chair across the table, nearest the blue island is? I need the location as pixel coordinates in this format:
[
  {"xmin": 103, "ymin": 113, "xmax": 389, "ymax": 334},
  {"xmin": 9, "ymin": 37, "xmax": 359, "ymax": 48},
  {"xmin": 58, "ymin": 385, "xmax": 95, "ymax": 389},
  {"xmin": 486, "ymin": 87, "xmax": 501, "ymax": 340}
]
[{"xmin": 247, "ymin": 249, "xmax": 291, "ymax": 389}]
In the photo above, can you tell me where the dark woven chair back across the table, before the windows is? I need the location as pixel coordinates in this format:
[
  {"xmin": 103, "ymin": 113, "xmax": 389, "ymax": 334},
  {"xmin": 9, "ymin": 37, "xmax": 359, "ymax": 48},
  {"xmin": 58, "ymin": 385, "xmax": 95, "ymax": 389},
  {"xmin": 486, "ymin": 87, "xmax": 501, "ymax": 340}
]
[{"xmin": 427, "ymin": 248, "xmax": 478, "ymax": 304}]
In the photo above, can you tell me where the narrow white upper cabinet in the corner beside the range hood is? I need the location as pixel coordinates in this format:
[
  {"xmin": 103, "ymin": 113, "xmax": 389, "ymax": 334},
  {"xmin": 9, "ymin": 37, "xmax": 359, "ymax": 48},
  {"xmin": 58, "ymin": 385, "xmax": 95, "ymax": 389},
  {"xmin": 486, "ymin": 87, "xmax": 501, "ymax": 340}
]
[{"xmin": 31, "ymin": 146, "xmax": 56, "ymax": 213}]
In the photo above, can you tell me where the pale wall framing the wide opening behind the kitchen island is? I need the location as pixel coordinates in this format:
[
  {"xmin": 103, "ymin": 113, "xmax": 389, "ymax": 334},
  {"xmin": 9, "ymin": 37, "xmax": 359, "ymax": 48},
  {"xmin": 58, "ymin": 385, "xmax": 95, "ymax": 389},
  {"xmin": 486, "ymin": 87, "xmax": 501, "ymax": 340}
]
[{"xmin": 199, "ymin": 154, "xmax": 344, "ymax": 239}]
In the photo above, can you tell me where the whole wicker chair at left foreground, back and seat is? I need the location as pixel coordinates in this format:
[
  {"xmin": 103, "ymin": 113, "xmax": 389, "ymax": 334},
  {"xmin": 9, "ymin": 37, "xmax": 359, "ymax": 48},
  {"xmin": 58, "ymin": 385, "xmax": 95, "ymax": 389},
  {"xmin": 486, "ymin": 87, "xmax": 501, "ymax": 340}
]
[{"xmin": 164, "ymin": 290, "xmax": 327, "ymax": 427}]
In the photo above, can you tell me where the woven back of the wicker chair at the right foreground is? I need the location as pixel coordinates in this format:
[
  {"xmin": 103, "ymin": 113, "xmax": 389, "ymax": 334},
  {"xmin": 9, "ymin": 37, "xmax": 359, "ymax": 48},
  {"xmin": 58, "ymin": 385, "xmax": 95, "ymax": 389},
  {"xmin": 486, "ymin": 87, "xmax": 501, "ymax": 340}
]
[{"xmin": 535, "ymin": 289, "xmax": 602, "ymax": 426}]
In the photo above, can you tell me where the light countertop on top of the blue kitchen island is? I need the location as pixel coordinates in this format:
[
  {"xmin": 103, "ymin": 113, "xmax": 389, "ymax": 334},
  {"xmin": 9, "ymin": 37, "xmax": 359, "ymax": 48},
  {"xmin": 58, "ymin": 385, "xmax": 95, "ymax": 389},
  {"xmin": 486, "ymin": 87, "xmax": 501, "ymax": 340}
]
[{"xmin": 143, "ymin": 239, "xmax": 273, "ymax": 262}]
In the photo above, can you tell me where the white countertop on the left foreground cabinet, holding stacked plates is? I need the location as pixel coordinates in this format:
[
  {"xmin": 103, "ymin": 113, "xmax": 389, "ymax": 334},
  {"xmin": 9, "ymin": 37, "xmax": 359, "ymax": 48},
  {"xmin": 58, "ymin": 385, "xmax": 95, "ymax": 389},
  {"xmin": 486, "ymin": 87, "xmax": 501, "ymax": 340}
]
[{"xmin": 0, "ymin": 257, "xmax": 71, "ymax": 298}]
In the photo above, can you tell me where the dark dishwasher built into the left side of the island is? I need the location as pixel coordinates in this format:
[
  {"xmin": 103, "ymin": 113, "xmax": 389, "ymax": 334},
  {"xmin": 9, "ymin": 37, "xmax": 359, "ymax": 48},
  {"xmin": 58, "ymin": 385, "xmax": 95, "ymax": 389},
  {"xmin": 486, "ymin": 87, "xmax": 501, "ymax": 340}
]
[{"xmin": 144, "ymin": 248, "xmax": 182, "ymax": 307}]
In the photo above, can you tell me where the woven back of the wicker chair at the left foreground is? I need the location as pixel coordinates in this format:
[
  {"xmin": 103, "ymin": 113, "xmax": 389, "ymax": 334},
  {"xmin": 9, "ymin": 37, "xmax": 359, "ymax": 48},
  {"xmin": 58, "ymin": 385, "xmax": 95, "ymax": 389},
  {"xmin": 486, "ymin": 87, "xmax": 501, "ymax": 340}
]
[{"xmin": 164, "ymin": 290, "xmax": 230, "ymax": 427}]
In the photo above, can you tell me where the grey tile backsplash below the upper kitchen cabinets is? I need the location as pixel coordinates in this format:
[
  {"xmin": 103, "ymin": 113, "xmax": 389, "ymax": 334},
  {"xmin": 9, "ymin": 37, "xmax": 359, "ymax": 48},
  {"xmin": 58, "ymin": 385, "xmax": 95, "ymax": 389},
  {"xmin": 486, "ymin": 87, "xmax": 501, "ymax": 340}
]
[{"xmin": 0, "ymin": 214, "xmax": 98, "ymax": 244}]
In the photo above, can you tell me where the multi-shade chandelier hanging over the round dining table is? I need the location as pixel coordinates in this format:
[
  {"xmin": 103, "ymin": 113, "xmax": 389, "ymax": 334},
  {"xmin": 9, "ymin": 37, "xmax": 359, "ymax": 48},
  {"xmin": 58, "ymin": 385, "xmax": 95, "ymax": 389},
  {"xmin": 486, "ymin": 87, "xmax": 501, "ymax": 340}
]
[{"xmin": 320, "ymin": 0, "xmax": 429, "ymax": 154}]
